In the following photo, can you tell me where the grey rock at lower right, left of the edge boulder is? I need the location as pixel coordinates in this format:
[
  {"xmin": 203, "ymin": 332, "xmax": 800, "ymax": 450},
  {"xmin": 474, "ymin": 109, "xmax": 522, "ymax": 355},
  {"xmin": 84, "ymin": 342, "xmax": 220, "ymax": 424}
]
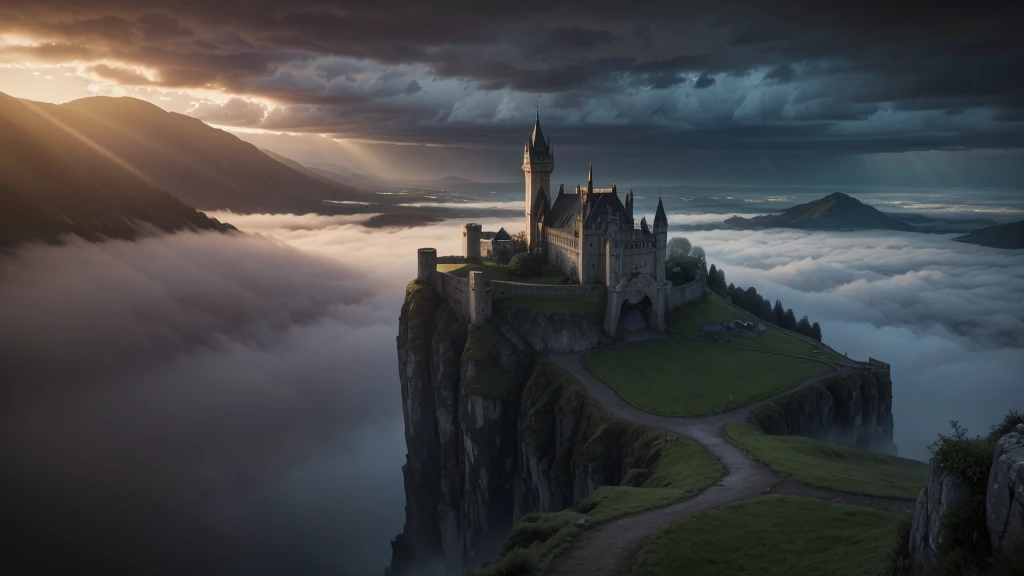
[{"xmin": 909, "ymin": 458, "xmax": 973, "ymax": 567}]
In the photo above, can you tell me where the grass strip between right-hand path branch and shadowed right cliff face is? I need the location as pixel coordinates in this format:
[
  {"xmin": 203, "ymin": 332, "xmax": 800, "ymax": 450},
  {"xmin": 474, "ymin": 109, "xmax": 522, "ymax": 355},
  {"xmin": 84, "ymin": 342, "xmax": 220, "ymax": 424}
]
[{"xmin": 725, "ymin": 424, "xmax": 928, "ymax": 500}]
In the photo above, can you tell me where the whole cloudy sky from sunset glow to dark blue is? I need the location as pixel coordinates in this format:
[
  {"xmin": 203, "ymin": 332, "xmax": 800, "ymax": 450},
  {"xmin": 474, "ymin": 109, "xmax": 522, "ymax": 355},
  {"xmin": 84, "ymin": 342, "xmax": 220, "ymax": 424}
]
[{"xmin": 0, "ymin": 0, "xmax": 1024, "ymax": 182}]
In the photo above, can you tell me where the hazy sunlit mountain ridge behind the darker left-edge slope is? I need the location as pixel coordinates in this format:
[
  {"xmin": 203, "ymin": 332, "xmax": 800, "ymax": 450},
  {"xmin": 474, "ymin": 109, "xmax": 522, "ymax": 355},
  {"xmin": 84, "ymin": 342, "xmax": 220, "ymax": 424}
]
[{"xmin": 49, "ymin": 97, "xmax": 365, "ymax": 212}]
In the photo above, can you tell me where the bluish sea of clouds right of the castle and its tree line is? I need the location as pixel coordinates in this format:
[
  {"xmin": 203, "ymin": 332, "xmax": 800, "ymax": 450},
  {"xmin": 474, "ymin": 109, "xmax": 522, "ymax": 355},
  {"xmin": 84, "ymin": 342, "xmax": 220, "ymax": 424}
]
[{"xmin": 683, "ymin": 230, "xmax": 1024, "ymax": 459}]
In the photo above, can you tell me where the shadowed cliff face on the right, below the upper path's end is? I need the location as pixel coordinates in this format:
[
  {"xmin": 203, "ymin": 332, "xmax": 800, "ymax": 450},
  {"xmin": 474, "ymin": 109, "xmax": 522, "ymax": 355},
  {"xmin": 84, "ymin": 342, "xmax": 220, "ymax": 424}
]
[{"xmin": 748, "ymin": 371, "xmax": 896, "ymax": 454}]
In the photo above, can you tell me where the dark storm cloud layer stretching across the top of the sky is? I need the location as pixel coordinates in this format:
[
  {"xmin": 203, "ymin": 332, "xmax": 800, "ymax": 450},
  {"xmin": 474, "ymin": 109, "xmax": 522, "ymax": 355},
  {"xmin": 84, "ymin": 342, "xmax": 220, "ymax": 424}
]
[{"xmin": 0, "ymin": 0, "xmax": 1024, "ymax": 152}]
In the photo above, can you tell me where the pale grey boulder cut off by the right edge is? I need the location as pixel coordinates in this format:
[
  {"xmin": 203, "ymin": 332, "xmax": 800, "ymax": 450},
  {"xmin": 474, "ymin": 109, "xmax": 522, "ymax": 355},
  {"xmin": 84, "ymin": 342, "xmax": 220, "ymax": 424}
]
[{"xmin": 985, "ymin": 424, "xmax": 1024, "ymax": 557}]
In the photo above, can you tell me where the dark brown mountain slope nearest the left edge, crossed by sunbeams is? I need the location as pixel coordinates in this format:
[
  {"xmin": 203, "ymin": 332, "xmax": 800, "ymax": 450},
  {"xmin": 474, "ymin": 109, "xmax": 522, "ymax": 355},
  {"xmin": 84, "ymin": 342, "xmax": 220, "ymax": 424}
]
[{"xmin": 0, "ymin": 93, "xmax": 234, "ymax": 248}]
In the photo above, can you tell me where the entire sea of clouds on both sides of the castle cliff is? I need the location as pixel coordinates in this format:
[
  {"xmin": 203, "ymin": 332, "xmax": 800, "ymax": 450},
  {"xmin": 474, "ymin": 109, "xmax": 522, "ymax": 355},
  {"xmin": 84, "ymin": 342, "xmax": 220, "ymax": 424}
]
[{"xmin": 0, "ymin": 213, "xmax": 1024, "ymax": 574}]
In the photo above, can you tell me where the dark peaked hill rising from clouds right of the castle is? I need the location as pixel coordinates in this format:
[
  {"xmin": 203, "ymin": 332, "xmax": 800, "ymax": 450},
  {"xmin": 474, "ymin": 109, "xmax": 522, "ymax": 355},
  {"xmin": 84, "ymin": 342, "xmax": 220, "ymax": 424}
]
[{"xmin": 725, "ymin": 192, "xmax": 915, "ymax": 232}]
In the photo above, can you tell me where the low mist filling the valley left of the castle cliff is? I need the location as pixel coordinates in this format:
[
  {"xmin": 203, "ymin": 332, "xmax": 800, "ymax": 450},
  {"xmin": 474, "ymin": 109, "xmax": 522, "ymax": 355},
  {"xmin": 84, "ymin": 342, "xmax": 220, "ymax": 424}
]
[{"xmin": 0, "ymin": 214, "xmax": 512, "ymax": 574}]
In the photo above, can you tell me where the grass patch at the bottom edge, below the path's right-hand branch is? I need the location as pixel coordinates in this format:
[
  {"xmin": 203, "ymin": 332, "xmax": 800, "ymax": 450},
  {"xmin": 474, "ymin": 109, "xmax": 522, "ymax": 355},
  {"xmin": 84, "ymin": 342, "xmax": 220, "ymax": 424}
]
[{"xmin": 631, "ymin": 496, "xmax": 902, "ymax": 576}]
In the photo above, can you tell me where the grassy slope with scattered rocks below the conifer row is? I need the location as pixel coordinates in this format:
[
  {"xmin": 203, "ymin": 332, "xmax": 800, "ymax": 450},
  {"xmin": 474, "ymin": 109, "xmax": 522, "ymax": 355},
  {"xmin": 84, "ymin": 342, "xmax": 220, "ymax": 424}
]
[{"xmin": 668, "ymin": 293, "xmax": 848, "ymax": 362}]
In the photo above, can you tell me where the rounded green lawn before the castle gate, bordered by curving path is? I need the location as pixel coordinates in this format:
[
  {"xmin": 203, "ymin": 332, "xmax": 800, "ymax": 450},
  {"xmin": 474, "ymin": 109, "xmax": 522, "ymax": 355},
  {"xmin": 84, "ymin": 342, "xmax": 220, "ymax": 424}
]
[{"xmin": 588, "ymin": 338, "xmax": 831, "ymax": 416}]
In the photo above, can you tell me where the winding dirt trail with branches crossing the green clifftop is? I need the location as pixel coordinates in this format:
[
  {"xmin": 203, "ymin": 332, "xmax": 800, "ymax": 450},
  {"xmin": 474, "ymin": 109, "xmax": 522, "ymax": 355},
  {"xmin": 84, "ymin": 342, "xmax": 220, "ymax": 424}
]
[{"xmin": 548, "ymin": 339, "xmax": 914, "ymax": 576}]
